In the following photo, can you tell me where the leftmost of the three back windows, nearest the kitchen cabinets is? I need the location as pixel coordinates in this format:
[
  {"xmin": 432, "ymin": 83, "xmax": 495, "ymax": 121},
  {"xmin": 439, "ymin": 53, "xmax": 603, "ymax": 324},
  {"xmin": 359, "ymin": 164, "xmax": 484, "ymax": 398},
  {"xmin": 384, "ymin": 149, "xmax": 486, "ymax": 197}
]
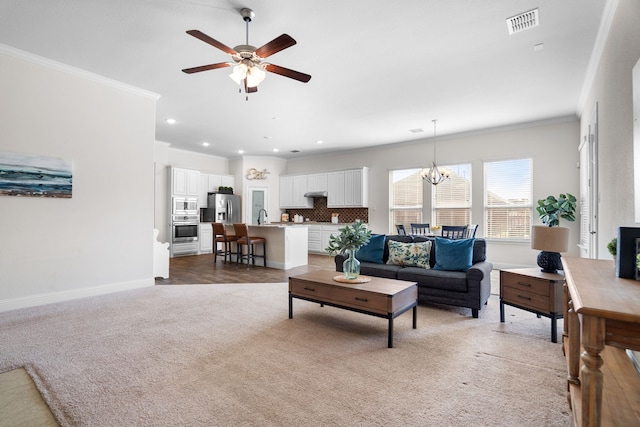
[{"xmin": 389, "ymin": 169, "xmax": 422, "ymax": 234}]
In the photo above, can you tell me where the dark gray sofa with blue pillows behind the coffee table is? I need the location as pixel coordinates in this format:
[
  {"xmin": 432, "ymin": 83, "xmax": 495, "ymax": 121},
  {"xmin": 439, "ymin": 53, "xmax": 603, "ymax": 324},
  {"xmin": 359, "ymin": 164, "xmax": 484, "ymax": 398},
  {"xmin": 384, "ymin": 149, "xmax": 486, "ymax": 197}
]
[{"xmin": 335, "ymin": 235, "xmax": 493, "ymax": 318}]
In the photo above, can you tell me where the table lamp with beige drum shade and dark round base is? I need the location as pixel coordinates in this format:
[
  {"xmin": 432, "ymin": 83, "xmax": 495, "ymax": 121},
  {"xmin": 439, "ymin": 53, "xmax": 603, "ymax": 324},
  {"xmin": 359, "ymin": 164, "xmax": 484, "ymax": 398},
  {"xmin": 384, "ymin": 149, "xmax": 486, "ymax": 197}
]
[{"xmin": 531, "ymin": 225, "xmax": 569, "ymax": 273}]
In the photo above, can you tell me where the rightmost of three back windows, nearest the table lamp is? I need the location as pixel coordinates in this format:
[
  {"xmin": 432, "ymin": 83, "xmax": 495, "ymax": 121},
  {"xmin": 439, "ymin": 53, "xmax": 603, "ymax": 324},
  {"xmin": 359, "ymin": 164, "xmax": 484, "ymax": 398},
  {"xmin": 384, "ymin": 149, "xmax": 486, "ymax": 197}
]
[{"xmin": 484, "ymin": 158, "xmax": 533, "ymax": 239}]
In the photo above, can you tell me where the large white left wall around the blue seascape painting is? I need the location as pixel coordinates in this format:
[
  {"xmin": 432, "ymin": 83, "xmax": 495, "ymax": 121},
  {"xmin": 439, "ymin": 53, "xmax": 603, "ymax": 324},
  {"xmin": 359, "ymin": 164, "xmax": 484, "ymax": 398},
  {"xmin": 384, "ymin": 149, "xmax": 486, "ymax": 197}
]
[{"xmin": 0, "ymin": 45, "xmax": 157, "ymax": 311}]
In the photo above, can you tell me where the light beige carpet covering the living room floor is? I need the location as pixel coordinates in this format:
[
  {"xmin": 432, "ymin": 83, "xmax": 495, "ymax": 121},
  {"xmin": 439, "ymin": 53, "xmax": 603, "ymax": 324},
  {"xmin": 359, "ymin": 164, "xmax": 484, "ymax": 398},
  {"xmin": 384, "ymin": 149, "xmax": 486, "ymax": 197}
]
[{"xmin": 0, "ymin": 283, "xmax": 573, "ymax": 427}]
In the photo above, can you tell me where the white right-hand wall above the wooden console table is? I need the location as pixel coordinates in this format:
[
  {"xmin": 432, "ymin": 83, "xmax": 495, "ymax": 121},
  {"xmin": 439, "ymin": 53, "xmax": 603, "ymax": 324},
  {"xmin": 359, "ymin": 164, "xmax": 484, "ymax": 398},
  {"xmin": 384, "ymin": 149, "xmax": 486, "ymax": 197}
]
[{"xmin": 580, "ymin": 0, "xmax": 640, "ymax": 259}]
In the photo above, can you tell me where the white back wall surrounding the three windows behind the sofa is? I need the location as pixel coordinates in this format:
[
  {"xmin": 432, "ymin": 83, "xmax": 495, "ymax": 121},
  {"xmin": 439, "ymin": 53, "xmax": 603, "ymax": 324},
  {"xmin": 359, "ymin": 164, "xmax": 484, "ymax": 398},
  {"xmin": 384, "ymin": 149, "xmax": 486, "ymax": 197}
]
[{"xmin": 287, "ymin": 118, "xmax": 579, "ymax": 268}]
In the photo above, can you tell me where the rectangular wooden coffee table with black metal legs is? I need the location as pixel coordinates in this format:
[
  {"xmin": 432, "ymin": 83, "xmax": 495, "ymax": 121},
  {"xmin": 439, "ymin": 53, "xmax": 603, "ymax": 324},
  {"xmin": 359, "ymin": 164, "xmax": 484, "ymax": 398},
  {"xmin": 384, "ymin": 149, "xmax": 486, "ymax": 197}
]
[{"xmin": 289, "ymin": 271, "xmax": 418, "ymax": 348}]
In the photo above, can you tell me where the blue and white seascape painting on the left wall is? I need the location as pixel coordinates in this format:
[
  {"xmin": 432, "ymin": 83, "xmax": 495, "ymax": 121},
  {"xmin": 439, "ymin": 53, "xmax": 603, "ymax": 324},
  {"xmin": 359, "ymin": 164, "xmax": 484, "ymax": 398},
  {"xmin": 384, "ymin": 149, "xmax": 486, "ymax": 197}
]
[{"xmin": 0, "ymin": 151, "xmax": 72, "ymax": 198}]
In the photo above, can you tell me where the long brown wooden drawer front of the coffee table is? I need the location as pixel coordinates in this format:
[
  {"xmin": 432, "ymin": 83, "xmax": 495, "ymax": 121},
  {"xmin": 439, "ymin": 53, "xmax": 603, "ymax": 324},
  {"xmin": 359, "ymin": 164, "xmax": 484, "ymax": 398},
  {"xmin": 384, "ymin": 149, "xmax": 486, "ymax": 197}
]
[{"xmin": 289, "ymin": 281, "xmax": 391, "ymax": 314}]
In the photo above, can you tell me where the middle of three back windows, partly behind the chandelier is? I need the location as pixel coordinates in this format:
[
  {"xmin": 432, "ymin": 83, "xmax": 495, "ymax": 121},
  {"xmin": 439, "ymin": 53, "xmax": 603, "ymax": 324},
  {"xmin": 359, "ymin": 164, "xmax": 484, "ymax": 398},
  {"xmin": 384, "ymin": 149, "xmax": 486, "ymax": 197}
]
[{"xmin": 431, "ymin": 163, "xmax": 471, "ymax": 225}]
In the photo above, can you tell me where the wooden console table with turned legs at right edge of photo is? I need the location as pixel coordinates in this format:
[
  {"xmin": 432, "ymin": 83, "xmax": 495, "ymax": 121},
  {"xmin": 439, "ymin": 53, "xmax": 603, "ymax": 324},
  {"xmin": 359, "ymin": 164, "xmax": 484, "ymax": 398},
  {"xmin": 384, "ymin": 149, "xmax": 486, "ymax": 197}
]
[{"xmin": 562, "ymin": 257, "xmax": 640, "ymax": 426}]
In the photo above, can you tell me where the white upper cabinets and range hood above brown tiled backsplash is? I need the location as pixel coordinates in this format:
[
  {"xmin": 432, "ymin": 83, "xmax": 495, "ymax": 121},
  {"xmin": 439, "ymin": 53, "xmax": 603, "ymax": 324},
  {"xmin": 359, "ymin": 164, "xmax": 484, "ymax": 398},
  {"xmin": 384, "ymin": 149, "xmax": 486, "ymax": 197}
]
[{"xmin": 280, "ymin": 168, "xmax": 369, "ymax": 209}]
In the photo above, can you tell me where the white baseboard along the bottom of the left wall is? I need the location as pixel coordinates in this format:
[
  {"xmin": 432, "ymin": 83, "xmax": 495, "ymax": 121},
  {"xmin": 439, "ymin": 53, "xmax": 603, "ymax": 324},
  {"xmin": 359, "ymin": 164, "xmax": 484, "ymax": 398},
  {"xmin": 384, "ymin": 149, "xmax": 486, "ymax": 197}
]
[{"xmin": 0, "ymin": 278, "xmax": 155, "ymax": 312}]
